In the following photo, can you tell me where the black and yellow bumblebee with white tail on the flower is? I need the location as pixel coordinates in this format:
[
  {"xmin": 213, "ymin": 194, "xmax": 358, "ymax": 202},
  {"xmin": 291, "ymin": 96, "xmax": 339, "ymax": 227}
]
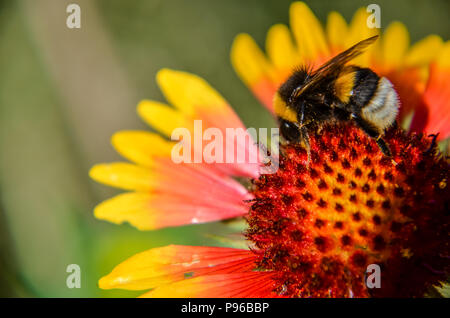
[{"xmin": 274, "ymin": 35, "xmax": 399, "ymax": 161}]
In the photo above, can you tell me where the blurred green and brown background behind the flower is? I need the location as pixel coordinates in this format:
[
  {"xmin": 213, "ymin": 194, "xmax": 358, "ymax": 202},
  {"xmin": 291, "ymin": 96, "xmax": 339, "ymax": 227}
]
[{"xmin": 0, "ymin": 0, "xmax": 450, "ymax": 297}]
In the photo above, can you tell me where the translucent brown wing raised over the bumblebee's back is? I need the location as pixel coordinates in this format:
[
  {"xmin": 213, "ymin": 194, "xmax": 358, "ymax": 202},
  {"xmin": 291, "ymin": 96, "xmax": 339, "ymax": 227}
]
[{"xmin": 293, "ymin": 35, "xmax": 378, "ymax": 97}]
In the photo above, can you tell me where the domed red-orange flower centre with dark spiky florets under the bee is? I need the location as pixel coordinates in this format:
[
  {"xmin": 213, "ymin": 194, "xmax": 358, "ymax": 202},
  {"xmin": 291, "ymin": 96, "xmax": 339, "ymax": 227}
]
[{"xmin": 246, "ymin": 124, "xmax": 450, "ymax": 297}]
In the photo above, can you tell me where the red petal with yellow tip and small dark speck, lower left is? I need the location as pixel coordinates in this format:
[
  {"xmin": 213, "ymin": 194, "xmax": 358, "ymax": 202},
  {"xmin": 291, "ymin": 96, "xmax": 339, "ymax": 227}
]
[{"xmin": 99, "ymin": 245, "xmax": 254, "ymax": 290}]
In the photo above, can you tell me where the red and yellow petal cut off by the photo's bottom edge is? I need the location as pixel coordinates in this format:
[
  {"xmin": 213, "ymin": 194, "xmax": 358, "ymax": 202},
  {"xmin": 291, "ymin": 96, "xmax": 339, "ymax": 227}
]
[{"xmin": 141, "ymin": 272, "xmax": 279, "ymax": 298}]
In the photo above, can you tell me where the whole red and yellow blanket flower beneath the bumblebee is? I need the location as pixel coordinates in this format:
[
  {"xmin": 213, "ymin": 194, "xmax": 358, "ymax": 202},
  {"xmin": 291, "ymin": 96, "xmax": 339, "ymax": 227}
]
[{"xmin": 91, "ymin": 2, "xmax": 450, "ymax": 297}]
